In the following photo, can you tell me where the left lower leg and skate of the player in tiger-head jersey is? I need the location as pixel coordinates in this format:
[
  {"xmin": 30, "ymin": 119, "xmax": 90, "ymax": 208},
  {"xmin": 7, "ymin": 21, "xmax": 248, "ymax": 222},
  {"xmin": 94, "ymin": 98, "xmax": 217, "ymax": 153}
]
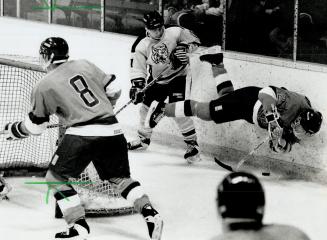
[{"xmin": 127, "ymin": 104, "xmax": 152, "ymax": 150}]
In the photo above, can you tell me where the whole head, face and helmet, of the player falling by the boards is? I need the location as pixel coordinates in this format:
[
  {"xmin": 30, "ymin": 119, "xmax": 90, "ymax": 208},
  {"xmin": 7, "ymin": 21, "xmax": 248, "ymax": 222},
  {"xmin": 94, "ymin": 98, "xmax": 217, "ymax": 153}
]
[{"xmin": 292, "ymin": 109, "xmax": 322, "ymax": 139}]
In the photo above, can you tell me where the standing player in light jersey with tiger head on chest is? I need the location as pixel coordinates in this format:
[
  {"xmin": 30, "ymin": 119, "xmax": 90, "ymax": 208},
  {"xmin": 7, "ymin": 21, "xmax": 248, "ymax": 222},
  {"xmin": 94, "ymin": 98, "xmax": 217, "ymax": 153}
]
[{"xmin": 128, "ymin": 11, "xmax": 201, "ymax": 163}]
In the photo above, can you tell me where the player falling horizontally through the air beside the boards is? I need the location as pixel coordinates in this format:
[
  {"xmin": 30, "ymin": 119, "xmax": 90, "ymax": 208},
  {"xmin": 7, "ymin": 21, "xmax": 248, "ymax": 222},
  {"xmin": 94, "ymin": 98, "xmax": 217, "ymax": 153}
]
[{"xmin": 145, "ymin": 54, "xmax": 322, "ymax": 152}]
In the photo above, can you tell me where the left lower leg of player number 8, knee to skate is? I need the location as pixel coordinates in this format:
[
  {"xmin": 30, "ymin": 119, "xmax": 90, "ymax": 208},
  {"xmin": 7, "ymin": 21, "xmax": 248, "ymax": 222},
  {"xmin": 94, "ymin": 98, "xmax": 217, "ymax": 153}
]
[{"xmin": 46, "ymin": 170, "xmax": 90, "ymax": 239}]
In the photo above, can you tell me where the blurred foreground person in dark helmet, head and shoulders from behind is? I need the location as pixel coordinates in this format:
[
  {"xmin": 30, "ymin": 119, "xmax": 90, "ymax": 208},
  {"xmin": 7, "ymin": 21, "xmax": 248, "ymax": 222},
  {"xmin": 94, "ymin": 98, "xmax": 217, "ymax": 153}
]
[{"xmin": 211, "ymin": 172, "xmax": 310, "ymax": 240}]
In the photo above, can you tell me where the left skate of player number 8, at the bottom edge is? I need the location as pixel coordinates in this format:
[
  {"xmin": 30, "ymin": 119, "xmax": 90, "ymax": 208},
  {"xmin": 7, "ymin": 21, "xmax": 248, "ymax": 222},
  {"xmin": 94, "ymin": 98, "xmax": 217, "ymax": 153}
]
[{"xmin": 55, "ymin": 218, "xmax": 90, "ymax": 240}]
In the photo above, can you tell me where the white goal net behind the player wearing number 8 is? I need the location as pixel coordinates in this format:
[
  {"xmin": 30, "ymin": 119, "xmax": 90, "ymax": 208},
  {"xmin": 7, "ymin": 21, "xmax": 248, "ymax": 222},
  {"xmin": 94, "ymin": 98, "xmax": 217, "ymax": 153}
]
[{"xmin": 0, "ymin": 56, "xmax": 134, "ymax": 217}]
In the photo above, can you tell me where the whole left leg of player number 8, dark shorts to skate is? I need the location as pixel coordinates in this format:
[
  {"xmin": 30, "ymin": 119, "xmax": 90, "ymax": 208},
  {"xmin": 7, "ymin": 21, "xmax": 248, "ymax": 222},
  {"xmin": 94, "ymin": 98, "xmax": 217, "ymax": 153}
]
[{"xmin": 46, "ymin": 135, "xmax": 92, "ymax": 239}]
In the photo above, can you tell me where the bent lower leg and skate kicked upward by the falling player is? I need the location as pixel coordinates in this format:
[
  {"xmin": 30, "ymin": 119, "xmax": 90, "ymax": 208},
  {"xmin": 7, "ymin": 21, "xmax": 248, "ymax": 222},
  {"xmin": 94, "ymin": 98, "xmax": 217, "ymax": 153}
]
[{"xmin": 200, "ymin": 53, "xmax": 234, "ymax": 97}]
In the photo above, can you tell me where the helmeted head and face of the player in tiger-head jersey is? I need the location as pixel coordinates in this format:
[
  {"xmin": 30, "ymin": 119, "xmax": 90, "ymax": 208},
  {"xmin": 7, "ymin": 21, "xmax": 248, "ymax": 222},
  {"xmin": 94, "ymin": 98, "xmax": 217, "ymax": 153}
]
[{"xmin": 143, "ymin": 11, "xmax": 165, "ymax": 40}]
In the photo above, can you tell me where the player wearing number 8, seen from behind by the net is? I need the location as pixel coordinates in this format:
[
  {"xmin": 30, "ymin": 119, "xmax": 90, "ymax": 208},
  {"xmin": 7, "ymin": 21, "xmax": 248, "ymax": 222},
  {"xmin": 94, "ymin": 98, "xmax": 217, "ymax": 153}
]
[{"xmin": 5, "ymin": 37, "xmax": 163, "ymax": 240}]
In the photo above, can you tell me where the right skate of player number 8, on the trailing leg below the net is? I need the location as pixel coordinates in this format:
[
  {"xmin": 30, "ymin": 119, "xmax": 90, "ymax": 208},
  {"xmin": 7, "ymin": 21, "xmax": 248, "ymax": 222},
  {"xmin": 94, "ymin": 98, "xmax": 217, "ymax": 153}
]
[{"xmin": 142, "ymin": 205, "xmax": 163, "ymax": 240}]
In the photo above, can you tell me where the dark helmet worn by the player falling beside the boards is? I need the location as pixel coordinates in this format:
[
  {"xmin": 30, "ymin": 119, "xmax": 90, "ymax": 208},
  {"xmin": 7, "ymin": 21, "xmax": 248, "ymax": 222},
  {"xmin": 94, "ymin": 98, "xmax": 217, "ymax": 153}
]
[{"xmin": 300, "ymin": 109, "xmax": 322, "ymax": 135}]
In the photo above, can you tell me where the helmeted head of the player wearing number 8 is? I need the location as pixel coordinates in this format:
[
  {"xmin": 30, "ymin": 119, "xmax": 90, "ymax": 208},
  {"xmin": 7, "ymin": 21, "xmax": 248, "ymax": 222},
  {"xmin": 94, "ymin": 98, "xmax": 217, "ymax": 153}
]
[{"xmin": 39, "ymin": 37, "xmax": 69, "ymax": 70}]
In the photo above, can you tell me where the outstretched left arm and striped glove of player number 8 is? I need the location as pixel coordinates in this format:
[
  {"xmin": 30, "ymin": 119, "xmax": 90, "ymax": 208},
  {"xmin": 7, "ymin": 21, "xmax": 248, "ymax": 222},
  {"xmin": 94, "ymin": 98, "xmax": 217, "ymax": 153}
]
[{"xmin": 5, "ymin": 86, "xmax": 50, "ymax": 140}]
